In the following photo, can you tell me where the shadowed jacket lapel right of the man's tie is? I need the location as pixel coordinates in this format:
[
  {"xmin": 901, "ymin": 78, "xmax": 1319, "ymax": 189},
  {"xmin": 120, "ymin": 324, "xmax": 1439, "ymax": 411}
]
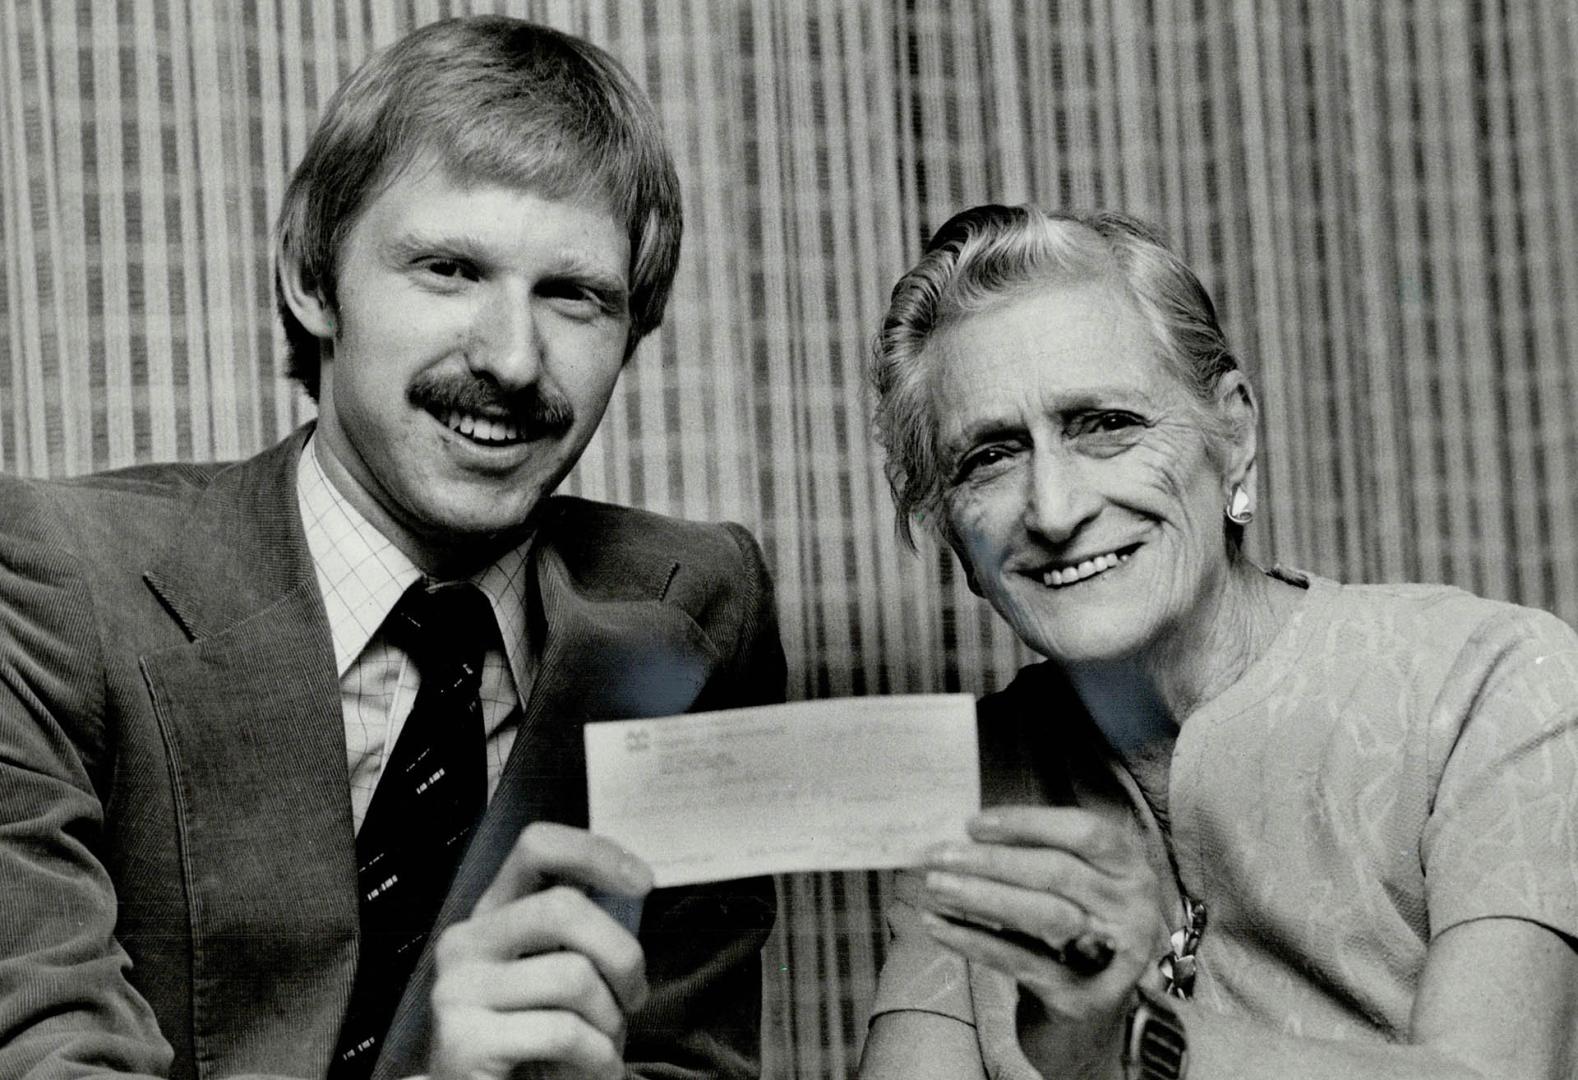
[{"xmin": 372, "ymin": 526, "xmax": 720, "ymax": 1080}]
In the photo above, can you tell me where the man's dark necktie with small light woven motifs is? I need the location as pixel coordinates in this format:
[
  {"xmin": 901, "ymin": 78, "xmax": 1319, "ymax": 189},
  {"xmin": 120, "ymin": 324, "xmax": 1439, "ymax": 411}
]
[{"xmin": 328, "ymin": 581, "xmax": 499, "ymax": 1080}]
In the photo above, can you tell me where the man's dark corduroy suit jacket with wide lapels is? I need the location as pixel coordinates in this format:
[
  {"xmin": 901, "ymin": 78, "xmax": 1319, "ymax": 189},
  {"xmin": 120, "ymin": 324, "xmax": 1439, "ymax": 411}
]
[{"xmin": 0, "ymin": 429, "xmax": 784, "ymax": 1080}]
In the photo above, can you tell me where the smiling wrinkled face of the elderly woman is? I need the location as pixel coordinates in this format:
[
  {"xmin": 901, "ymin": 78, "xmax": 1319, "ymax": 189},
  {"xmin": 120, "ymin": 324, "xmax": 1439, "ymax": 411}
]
[{"xmin": 933, "ymin": 284, "xmax": 1226, "ymax": 663}]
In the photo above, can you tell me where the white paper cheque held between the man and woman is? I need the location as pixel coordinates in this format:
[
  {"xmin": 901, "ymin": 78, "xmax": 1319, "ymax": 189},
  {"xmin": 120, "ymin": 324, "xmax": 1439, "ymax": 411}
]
[{"xmin": 585, "ymin": 693, "xmax": 980, "ymax": 886}]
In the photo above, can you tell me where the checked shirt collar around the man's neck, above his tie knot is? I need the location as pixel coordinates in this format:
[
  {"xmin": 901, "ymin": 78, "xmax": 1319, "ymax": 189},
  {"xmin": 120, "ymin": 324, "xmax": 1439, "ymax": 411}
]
[{"xmin": 297, "ymin": 437, "xmax": 532, "ymax": 687}]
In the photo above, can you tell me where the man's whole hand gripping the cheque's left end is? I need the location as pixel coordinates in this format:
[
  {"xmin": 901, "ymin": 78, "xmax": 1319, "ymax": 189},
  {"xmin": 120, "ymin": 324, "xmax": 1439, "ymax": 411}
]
[{"xmin": 429, "ymin": 823, "xmax": 652, "ymax": 1080}]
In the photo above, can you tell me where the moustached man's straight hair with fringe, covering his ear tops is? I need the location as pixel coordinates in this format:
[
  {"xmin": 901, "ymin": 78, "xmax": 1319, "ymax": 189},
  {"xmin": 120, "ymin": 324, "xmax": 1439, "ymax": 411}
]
[{"xmin": 275, "ymin": 16, "xmax": 682, "ymax": 398}]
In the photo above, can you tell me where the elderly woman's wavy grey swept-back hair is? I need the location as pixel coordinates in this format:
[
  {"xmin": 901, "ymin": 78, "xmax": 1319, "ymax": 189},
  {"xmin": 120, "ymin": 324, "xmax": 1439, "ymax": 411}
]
[{"xmin": 871, "ymin": 204, "xmax": 1242, "ymax": 546}]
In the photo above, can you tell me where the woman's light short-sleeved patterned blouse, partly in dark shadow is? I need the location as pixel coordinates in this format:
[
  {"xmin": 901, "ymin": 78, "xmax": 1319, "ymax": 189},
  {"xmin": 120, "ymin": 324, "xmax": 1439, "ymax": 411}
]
[{"xmin": 873, "ymin": 570, "xmax": 1578, "ymax": 1080}]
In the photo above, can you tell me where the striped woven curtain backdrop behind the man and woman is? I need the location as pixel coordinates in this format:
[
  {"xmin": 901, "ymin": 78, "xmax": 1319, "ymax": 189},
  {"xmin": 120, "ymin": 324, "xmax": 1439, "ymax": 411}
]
[{"xmin": 0, "ymin": 0, "xmax": 1578, "ymax": 1077}]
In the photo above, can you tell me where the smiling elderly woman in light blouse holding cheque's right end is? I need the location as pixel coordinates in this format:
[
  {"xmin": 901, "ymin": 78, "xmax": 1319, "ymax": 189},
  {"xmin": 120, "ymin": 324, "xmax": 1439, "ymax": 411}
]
[{"xmin": 862, "ymin": 207, "xmax": 1578, "ymax": 1080}]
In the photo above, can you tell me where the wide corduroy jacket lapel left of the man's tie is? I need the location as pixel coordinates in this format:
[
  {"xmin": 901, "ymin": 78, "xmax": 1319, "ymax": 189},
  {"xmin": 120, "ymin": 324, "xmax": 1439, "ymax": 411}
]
[{"xmin": 142, "ymin": 431, "xmax": 357, "ymax": 1074}]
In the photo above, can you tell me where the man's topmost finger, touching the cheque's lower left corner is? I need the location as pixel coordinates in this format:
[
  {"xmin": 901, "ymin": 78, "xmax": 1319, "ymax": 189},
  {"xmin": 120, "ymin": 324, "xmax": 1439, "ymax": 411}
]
[{"xmin": 472, "ymin": 821, "xmax": 652, "ymax": 916}]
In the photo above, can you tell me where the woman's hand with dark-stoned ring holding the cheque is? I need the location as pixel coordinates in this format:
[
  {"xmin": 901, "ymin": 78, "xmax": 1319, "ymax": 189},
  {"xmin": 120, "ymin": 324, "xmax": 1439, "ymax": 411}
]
[{"xmin": 922, "ymin": 807, "xmax": 1168, "ymax": 1037}]
